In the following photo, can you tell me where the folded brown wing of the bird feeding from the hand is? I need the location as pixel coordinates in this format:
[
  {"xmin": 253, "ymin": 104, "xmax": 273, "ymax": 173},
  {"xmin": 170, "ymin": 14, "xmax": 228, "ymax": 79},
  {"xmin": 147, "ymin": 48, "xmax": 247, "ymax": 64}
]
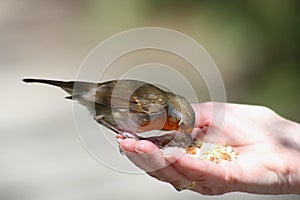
[{"xmin": 75, "ymin": 80, "xmax": 167, "ymax": 114}]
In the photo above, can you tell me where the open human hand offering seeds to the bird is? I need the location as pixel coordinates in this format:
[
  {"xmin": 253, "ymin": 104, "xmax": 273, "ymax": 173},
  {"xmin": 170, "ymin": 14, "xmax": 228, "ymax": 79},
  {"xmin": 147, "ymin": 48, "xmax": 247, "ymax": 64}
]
[{"xmin": 120, "ymin": 103, "xmax": 300, "ymax": 195}]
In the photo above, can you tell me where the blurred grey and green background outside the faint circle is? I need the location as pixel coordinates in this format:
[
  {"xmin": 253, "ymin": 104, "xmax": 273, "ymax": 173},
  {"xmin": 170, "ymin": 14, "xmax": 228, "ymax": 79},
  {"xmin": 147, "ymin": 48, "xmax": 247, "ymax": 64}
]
[{"xmin": 0, "ymin": 0, "xmax": 300, "ymax": 200}]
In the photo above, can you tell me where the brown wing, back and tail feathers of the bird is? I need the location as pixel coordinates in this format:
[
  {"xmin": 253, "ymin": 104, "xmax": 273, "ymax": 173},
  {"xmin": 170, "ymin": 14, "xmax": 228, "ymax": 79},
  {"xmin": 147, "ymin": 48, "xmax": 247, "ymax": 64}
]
[{"xmin": 23, "ymin": 79, "xmax": 167, "ymax": 114}]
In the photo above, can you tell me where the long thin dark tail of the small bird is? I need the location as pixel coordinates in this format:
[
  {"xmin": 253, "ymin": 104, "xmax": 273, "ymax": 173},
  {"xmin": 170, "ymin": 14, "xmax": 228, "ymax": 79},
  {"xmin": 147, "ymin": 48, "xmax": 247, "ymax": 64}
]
[{"xmin": 23, "ymin": 78, "xmax": 97, "ymax": 95}]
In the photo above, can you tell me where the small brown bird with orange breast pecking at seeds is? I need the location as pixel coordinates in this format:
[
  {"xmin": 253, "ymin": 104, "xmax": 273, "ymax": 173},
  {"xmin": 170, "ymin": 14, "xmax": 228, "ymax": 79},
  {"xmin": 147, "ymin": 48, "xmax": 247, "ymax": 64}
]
[{"xmin": 23, "ymin": 78, "xmax": 195, "ymax": 147}]
